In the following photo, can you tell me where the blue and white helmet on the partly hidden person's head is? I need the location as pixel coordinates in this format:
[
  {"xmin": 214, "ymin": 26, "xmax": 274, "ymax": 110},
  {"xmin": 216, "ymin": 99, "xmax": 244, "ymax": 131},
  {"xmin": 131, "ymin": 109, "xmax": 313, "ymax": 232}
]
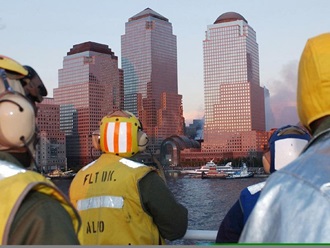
[{"xmin": 262, "ymin": 125, "xmax": 311, "ymax": 173}]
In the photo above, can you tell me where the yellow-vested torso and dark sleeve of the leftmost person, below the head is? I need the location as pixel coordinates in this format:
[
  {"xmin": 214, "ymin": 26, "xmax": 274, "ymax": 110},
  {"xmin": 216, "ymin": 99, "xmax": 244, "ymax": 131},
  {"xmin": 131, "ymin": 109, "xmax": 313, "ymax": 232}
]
[{"xmin": 0, "ymin": 159, "xmax": 80, "ymax": 245}]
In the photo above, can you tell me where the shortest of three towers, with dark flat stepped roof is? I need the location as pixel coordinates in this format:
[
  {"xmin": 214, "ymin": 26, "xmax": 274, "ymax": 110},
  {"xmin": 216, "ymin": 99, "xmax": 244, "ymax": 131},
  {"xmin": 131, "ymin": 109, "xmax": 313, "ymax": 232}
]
[{"xmin": 54, "ymin": 42, "xmax": 123, "ymax": 166}]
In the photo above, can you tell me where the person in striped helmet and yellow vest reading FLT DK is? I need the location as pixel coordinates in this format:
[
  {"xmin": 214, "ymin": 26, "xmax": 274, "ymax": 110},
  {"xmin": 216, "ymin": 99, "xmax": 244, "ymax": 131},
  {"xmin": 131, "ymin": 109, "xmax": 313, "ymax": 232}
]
[{"xmin": 69, "ymin": 111, "xmax": 188, "ymax": 245}]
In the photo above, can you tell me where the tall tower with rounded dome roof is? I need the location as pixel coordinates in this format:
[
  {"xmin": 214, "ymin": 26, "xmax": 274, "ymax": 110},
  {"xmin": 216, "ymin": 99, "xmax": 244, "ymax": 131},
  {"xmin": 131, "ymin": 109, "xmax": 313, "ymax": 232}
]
[{"xmin": 202, "ymin": 12, "xmax": 266, "ymax": 153}]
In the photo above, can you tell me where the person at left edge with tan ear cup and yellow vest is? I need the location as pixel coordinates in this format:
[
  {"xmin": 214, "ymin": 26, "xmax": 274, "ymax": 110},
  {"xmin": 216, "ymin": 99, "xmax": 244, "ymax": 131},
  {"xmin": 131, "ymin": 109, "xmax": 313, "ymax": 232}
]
[{"xmin": 0, "ymin": 55, "xmax": 81, "ymax": 245}]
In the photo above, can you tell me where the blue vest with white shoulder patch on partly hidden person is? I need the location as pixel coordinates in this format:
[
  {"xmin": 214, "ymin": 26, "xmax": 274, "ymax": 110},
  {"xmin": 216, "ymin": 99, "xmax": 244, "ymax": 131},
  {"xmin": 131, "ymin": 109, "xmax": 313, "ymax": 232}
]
[{"xmin": 239, "ymin": 182, "xmax": 265, "ymax": 224}]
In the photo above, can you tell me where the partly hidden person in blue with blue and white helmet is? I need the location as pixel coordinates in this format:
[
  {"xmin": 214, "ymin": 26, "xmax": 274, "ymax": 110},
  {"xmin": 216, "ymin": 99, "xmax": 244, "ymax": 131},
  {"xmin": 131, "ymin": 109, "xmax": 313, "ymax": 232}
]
[{"xmin": 216, "ymin": 125, "xmax": 310, "ymax": 243}]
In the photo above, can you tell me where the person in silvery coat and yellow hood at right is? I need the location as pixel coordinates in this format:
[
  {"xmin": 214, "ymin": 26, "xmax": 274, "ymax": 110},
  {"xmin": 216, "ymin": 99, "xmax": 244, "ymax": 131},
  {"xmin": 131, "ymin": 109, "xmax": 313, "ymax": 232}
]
[{"xmin": 239, "ymin": 33, "xmax": 330, "ymax": 244}]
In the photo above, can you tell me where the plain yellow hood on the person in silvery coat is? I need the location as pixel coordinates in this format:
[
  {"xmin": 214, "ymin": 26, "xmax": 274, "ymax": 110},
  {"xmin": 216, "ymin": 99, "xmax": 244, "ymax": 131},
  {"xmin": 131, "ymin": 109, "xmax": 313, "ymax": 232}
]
[{"xmin": 297, "ymin": 33, "xmax": 330, "ymax": 130}]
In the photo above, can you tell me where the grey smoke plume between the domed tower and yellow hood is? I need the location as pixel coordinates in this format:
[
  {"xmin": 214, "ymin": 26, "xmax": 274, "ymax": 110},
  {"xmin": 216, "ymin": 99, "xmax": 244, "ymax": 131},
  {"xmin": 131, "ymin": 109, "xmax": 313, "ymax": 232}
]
[{"xmin": 266, "ymin": 61, "xmax": 299, "ymax": 128}]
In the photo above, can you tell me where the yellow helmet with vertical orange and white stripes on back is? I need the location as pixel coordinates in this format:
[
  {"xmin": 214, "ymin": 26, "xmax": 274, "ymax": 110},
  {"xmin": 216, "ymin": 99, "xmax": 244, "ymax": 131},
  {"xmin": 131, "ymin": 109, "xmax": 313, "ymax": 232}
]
[{"xmin": 100, "ymin": 110, "xmax": 142, "ymax": 157}]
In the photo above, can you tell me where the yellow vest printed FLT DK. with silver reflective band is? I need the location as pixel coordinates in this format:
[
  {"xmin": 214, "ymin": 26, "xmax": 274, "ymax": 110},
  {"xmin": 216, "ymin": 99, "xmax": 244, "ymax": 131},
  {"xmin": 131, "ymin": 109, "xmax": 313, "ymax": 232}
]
[{"xmin": 69, "ymin": 154, "xmax": 164, "ymax": 245}]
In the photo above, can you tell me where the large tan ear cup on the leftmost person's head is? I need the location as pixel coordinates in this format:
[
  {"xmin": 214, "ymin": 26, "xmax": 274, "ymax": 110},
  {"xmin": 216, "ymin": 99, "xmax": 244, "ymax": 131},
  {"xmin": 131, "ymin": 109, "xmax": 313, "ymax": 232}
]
[{"xmin": 0, "ymin": 69, "xmax": 36, "ymax": 150}]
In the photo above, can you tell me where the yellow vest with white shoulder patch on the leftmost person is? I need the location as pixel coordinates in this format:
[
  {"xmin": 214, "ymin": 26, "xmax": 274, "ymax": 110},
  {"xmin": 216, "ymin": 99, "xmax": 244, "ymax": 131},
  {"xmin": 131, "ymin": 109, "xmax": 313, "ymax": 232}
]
[{"xmin": 0, "ymin": 160, "xmax": 81, "ymax": 245}]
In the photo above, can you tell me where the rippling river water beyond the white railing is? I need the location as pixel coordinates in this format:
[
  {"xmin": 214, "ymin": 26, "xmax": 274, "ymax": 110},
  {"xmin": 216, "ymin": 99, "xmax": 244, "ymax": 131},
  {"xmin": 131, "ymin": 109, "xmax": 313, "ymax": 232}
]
[{"xmin": 53, "ymin": 176, "xmax": 265, "ymax": 245}]
